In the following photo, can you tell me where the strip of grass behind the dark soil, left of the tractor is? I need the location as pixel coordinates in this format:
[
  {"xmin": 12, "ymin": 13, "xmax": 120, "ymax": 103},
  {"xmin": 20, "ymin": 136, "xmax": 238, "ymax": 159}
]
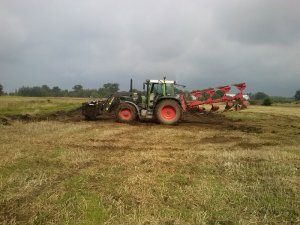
[{"xmin": 0, "ymin": 96, "xmax": 85, "ymax": 117}]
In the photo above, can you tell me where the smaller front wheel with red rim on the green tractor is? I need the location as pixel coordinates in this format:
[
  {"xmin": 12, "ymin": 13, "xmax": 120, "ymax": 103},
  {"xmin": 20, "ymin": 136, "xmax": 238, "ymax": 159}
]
[{"xmin": 115, "ymin": 103, "xmax": 137, "ymax": 123}]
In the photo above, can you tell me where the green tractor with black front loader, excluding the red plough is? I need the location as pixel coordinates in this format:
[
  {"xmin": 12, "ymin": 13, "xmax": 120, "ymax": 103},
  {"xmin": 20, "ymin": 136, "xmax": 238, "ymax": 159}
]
[{"xmin": 82, "ymin": 78, "xmax": 183, "ymax": 125}]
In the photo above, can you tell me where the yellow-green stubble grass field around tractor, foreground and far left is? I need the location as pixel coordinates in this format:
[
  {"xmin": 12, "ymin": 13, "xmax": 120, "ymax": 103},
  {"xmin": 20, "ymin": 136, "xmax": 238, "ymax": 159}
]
[{"xmin": 0, "ymin": 97, "xmax": 300, "ymax": 225}]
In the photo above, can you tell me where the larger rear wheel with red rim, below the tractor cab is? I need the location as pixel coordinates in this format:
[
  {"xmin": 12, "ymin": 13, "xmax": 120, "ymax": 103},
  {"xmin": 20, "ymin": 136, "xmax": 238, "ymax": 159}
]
[{"xmin": 155, "ymin": 100, "xmax": 181, "ymax": 125}]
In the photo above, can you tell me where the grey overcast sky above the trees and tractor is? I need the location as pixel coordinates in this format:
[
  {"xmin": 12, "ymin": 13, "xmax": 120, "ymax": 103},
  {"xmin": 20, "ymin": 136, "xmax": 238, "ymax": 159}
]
[{"xmin": 0, "ymin": 0, "xmax": 300, "ymax": 96}]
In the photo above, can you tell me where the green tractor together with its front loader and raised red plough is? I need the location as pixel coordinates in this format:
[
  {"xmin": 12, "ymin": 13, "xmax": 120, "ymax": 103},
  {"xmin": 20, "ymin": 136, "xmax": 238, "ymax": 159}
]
[{"xmin": 82, "ymin": 77, "xmax": 249, "ymax": 125}]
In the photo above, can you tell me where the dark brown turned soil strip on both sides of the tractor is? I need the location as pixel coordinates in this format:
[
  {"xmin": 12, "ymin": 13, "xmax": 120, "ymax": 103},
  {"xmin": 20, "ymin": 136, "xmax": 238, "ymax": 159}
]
[{"xmin": 0, "ymin": 107, "xmax": 262, "ymax": 133}]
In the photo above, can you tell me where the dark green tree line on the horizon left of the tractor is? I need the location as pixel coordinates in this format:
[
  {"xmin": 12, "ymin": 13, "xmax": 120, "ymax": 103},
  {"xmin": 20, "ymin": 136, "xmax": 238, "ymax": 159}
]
[{"xmin": 0, "ymin": 83, "xmax": 119, "ymax": 98}]
